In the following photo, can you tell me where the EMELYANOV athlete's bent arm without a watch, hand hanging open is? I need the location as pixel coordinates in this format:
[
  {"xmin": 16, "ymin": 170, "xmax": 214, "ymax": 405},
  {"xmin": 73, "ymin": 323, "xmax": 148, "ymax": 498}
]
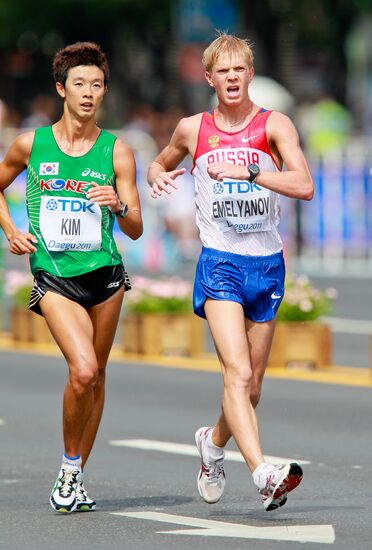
[{"xmin": 147, "ymin": 115, "xmax": 199, "ymax": 199}]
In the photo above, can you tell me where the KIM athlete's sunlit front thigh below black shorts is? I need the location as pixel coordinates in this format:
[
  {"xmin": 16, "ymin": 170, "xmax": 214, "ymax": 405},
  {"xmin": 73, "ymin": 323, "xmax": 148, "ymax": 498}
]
[{"xmin": 40, "ymin": 291, "xmax": 96, "ymax": 368}]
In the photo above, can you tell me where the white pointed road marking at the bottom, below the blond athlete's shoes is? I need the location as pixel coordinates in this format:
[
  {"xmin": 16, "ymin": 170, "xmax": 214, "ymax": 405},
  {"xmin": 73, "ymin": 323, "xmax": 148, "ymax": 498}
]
[{"xmin": 112, "ymin": 512, "xmax": 336, "ymax": 544}]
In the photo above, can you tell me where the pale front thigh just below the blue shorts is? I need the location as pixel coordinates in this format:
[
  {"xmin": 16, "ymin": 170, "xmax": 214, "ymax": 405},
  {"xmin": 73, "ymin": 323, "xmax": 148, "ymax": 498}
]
[{"xmin": 205, "ymin": 299, "xmax": 250, "ymax": 378}]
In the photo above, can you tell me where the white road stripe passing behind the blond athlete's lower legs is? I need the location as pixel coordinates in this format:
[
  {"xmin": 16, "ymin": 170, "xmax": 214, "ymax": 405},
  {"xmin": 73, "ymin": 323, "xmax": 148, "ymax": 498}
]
[{"xmin": 109, "ymin": 439, "xmax": 310, "ymax": 464}]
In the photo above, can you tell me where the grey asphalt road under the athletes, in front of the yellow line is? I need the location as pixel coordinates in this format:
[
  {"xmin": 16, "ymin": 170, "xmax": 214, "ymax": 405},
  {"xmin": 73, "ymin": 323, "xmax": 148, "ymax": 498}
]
[{"xmin": 0, "ymin": 352, "xmax": 372, "ymax": 550}]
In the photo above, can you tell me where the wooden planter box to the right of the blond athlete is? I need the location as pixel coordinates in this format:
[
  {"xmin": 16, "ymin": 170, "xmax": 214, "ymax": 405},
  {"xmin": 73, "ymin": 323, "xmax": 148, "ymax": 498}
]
[{"xmin": 268, "ymin": 321, "xmax": 332, "ymax": 369}]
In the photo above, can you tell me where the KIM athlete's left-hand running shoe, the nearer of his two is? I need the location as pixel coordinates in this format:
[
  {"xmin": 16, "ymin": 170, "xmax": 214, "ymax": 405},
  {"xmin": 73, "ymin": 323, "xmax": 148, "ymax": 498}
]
[{"xmin": 50, "ymin": 464, "xmax": 81, "ymax": 514}]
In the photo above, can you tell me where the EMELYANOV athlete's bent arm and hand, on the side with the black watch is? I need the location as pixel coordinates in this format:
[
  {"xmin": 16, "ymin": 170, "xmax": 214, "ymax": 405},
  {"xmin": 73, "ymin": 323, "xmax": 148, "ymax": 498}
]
[{"xmin": 208, "ymin": 112, "xmax": 314, "ymax": 200}]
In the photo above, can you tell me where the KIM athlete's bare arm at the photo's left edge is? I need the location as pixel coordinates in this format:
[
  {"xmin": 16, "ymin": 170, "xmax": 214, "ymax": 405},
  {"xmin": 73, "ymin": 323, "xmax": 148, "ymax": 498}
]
[{"xmin": 0, "ymin": 132, "xmax": 37, "ymax": 255}]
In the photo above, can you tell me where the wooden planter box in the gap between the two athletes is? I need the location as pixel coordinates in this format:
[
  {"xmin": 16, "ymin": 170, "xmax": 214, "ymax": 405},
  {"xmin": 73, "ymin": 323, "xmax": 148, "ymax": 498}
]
[{"xmin": 122, "ymin": 313, "xmax": 204, "ymax": 356}]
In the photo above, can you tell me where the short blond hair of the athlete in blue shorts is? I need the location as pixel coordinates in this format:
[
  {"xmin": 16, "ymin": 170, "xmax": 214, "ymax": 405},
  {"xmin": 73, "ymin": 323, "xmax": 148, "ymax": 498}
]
[{"xmin": 202, "ymin": 32, "xmax": 253, "ymax": 73}]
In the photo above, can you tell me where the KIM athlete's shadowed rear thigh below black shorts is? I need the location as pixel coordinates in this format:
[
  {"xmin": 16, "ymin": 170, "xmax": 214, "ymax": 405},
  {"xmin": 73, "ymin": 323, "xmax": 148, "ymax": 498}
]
[{"xmin": 88, "ymin": 286, "xmax": 124, "ymax": 368}]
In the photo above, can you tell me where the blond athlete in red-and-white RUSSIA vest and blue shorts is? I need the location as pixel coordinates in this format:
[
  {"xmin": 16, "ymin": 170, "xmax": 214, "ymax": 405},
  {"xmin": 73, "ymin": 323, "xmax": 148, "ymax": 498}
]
[{"xmin": 148, "ymin": 34, "xmax": 313, "ymax": 510}]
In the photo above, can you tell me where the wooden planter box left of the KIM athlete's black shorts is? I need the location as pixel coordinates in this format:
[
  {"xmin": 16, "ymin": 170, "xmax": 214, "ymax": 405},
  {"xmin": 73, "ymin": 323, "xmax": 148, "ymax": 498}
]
[{"xmin": 9, "ymin": 307, "xmax": 54, "ymax": 343}]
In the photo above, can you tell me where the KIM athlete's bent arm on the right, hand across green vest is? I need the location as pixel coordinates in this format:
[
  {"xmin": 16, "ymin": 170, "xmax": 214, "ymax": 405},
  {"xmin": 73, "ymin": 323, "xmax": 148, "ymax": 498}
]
[{"xmin": 87, "ymin": 139, "xmax": 143, "ymax": 240}]
